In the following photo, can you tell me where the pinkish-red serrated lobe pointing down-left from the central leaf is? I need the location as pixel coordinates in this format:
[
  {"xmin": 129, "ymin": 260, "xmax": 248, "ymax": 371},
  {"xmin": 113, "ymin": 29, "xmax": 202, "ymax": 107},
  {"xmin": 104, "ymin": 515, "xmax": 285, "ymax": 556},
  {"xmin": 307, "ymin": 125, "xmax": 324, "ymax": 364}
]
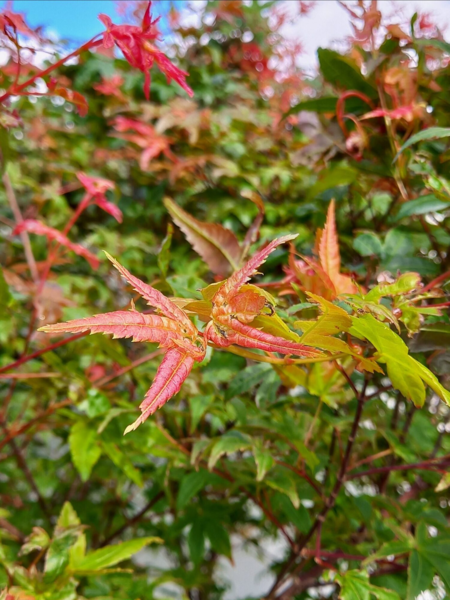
[{"xmin": 124, "ymin": 349, "xmax": 194, "ymax": 435}]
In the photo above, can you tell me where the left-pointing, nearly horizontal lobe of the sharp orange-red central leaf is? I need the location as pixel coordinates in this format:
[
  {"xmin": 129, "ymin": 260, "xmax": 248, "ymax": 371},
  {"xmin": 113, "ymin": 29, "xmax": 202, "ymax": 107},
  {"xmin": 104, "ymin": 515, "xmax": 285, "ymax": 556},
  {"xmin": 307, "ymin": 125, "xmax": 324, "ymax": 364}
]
[{"xmin": 39, "ymin": 310, "xmax": 182, "ymax": 348}]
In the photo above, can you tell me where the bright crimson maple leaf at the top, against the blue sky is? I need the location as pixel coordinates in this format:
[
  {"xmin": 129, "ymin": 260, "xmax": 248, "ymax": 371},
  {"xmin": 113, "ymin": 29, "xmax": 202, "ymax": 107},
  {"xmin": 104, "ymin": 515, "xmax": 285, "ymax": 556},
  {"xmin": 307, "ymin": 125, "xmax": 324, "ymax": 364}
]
[{"xmin": 99, "ymin": 2, "xmax": 194, "ymax": 100}]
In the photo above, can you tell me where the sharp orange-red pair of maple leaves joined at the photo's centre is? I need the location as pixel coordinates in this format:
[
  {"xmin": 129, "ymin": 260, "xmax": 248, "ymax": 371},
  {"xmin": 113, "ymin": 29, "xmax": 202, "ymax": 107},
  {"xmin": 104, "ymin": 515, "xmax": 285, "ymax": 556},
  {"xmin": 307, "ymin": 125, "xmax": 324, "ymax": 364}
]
[{"xmin": 39, "ymin": 235, "xmax": 321, "ymax": 433}]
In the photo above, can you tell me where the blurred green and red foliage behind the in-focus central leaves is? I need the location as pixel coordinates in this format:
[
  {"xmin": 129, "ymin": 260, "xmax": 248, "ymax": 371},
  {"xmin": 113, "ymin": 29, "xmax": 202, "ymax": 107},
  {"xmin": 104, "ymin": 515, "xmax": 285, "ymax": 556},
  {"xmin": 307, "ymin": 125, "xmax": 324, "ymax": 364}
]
[{"xmin": 0, "ymin": 0, "xmax": 450, "ymax": 600}]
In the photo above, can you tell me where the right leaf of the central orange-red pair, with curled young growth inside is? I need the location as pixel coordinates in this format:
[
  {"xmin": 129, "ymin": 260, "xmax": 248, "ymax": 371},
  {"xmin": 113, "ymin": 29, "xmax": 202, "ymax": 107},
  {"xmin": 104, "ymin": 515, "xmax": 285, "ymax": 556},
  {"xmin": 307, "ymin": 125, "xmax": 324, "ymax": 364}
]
[{"xmin": 204, "ymin": 235, "xmax": 321, "ymax": 356}]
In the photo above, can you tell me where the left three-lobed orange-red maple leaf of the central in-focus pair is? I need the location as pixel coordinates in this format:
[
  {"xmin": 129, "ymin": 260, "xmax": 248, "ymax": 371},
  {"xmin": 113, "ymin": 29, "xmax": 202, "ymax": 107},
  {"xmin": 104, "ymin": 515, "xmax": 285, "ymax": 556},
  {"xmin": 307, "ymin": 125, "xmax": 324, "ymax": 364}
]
[{"xmin": 39, "ymin": 253, "xmax": 205, "ymax": 433}]
